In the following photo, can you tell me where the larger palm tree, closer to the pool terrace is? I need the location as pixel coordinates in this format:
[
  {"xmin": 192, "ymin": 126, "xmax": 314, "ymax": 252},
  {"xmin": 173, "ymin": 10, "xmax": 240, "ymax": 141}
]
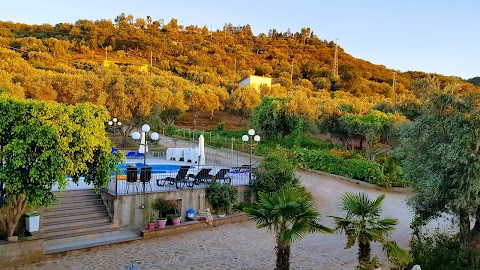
[{"xmin": 243, "ymin": 188, "xmax": 333, "ymax": 270}]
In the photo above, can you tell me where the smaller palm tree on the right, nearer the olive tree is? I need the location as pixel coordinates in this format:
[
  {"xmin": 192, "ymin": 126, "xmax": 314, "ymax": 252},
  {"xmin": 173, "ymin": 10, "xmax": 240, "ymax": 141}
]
[{"xmin": 332, "ymin": 192, "xmax": 402, "ymax": 266}]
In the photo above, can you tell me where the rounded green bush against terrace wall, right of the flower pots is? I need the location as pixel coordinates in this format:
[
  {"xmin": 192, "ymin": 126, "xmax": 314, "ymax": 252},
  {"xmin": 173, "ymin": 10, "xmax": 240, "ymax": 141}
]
[{"xmin": 207, "ymin": 180, "xmax": 238, "ymax": 217}]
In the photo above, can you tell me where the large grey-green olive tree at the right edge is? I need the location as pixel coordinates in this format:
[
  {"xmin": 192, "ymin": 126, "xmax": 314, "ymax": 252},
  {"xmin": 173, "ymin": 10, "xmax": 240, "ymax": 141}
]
[{"xmin": 401, "ymin": 94, "xmax": 480, "ymax": 251}]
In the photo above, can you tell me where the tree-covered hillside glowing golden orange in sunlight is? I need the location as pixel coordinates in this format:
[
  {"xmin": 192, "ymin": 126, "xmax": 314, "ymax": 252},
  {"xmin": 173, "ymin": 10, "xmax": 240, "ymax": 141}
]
[{"xmin": 0, "ymin": 14, "xmax": 479, "ymax": 130}]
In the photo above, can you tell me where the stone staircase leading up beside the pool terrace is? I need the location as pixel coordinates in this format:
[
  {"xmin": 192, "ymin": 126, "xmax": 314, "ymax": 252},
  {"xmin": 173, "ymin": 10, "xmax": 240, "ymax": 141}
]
[{"xmin": 43, "ymin": 189, "xmax": 120, "ymax": 252}]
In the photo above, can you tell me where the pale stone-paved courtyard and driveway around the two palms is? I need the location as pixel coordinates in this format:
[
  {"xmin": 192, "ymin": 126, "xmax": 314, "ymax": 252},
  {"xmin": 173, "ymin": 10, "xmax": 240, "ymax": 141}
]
[{"xmin": 7, "ymin": 136, "xmax": 428, "ymax": 270}]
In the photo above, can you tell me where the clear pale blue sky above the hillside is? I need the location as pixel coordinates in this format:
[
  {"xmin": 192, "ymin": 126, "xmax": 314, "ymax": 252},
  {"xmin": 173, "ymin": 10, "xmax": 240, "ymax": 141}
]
[{"xmin": 0, "ymin": 0, "xmax": 480, "ymax": 79}]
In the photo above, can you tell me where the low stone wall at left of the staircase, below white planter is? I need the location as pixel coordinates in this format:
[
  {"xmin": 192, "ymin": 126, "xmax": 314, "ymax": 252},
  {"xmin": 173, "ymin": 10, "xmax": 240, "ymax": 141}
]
[{"xmin": 0, "ymin": 236, "xmax": 45, "ymax": 268}]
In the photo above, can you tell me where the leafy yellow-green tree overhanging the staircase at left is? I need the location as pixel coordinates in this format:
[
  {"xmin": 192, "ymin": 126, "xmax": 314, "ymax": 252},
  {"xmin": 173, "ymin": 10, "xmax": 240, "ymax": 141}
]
[{"xmin": 0, "ymin": 98, "xmax": 120, "ymax": 236}]
